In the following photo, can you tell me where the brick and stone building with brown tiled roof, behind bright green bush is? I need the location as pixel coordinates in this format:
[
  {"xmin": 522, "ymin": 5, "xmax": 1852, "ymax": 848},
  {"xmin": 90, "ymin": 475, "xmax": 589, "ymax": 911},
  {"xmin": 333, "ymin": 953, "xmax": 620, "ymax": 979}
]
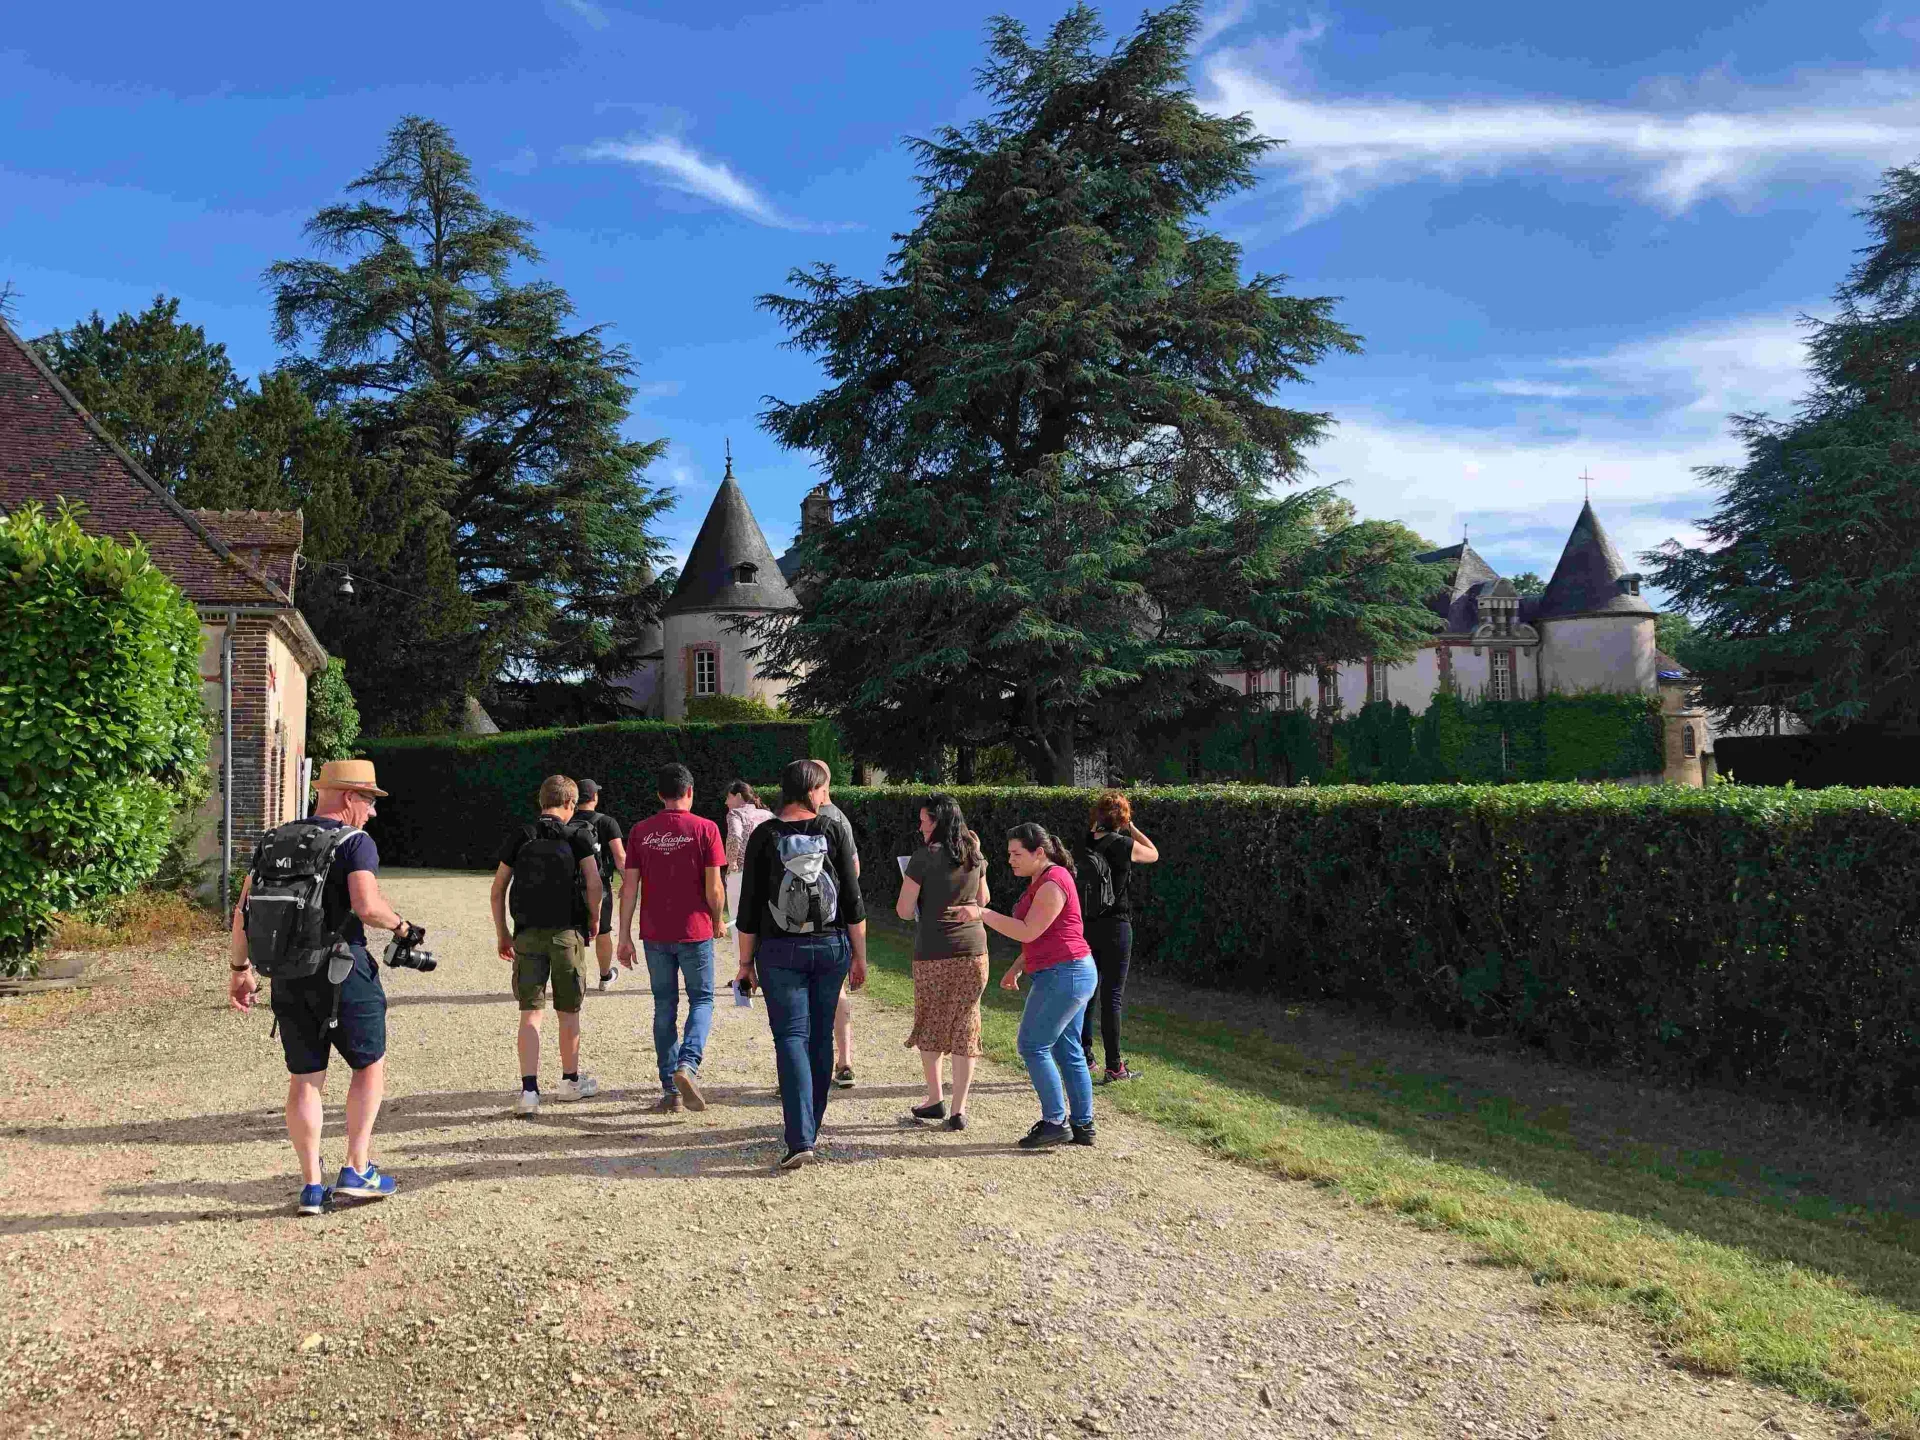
[{"xmin": 0, "ymin": 321, "xmax": 326, "ymax": 898}]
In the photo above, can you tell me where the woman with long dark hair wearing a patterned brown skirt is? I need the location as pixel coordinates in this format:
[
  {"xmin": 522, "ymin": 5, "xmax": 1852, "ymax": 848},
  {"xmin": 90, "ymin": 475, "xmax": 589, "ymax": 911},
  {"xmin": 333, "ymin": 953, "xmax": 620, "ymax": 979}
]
[{"xmin": 893, "ymin": 795, "xmax": 987, "ymax": 1131}]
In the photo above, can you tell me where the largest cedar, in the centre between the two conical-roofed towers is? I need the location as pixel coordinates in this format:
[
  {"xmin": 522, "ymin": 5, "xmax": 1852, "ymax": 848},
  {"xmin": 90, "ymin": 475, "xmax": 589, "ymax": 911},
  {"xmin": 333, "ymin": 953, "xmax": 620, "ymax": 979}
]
[{"xmin": 753, "ymin": 4, "xmax": 1432, "ymax": 781}]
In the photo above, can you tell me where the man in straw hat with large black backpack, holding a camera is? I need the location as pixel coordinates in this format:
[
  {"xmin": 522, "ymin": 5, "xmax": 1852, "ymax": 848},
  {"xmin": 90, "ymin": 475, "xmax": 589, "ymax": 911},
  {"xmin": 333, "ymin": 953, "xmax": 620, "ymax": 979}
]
[{"xmin": 228, "ymin": 760, "xmax": 409, "ymax": 1215}]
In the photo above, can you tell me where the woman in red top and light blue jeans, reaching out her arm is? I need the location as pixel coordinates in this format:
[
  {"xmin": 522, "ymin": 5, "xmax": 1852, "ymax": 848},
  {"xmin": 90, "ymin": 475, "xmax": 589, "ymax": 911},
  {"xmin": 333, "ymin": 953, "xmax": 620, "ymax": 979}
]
[{"xmin": 954, "ymin": 822, "xmax": 1100, "ymax": 1150}]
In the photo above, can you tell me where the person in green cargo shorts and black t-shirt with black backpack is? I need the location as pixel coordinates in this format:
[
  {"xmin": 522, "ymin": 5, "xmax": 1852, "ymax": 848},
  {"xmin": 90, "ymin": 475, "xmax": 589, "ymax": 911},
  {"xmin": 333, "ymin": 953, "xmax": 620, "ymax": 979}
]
[{"xmin": 492, "ymin": 776, "xmax": 601, "ymax": 1116}]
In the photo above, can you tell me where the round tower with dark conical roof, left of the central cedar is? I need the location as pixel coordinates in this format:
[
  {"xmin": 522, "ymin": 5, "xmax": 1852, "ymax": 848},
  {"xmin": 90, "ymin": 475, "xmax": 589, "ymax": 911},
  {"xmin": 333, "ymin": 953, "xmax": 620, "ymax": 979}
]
[{"xmin": 660, "ymin": 455, "xmax": 795, "ymax": 720}]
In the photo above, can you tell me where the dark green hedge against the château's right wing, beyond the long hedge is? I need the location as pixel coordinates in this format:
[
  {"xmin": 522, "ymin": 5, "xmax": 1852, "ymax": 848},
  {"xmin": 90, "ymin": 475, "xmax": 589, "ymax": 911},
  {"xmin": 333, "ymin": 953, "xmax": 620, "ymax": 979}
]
[{"xmin": 1139, "ymin": 691, "xmax": 1665, "ymax": 785}]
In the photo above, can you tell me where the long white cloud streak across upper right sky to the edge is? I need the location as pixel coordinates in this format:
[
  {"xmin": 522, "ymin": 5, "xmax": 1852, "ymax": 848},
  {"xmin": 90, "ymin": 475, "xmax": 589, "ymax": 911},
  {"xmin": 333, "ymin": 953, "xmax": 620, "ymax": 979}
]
[{"xmin": 1208, "ymin": 42, "xmax": 1920, "ymax": 223}]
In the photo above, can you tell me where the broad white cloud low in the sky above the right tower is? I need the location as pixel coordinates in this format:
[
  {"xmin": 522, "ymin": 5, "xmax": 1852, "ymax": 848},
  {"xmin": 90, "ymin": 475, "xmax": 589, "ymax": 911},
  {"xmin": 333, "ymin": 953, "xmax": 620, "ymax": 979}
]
[{"xmin": 1311, "ymin": 311, "xmax": 1807, "ymax": 574}]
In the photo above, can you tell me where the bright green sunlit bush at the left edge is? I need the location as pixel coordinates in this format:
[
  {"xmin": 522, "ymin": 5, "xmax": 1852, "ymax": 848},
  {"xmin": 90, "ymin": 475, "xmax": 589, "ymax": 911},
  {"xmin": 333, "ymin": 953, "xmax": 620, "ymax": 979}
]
[{"xmin": 0, "ymin": 505, "xmax": 207, "ymax": 973}]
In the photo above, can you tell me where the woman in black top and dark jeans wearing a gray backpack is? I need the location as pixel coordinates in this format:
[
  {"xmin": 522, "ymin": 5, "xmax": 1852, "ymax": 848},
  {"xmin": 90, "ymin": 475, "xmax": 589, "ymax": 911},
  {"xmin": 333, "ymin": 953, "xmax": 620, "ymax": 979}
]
[{"xmin": 733, "ymin": 760, "xmax": 866, "ymax": 1169}]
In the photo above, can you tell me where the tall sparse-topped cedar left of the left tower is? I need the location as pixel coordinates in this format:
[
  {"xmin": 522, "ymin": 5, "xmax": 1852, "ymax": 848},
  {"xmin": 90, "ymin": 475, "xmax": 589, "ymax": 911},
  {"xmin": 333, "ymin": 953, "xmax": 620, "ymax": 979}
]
[{"xmin": 267, "ymin": 117, "xmax": 672, "ymax": 695}]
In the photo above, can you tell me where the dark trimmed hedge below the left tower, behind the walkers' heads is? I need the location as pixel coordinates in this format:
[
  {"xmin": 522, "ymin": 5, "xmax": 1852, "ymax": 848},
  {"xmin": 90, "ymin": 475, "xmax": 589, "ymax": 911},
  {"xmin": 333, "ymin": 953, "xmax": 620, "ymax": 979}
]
[{"xmin": 361, "ymin": 720, "xmax": 808, "ymax": 870}]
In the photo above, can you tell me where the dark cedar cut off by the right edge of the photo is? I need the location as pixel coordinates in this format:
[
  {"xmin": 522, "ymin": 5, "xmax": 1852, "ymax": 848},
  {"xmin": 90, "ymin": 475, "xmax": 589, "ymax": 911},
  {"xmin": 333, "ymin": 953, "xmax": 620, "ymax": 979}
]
[{"xmin": 1645, "ymin": 167, "xmax": 1920, "ymax": 732}]
